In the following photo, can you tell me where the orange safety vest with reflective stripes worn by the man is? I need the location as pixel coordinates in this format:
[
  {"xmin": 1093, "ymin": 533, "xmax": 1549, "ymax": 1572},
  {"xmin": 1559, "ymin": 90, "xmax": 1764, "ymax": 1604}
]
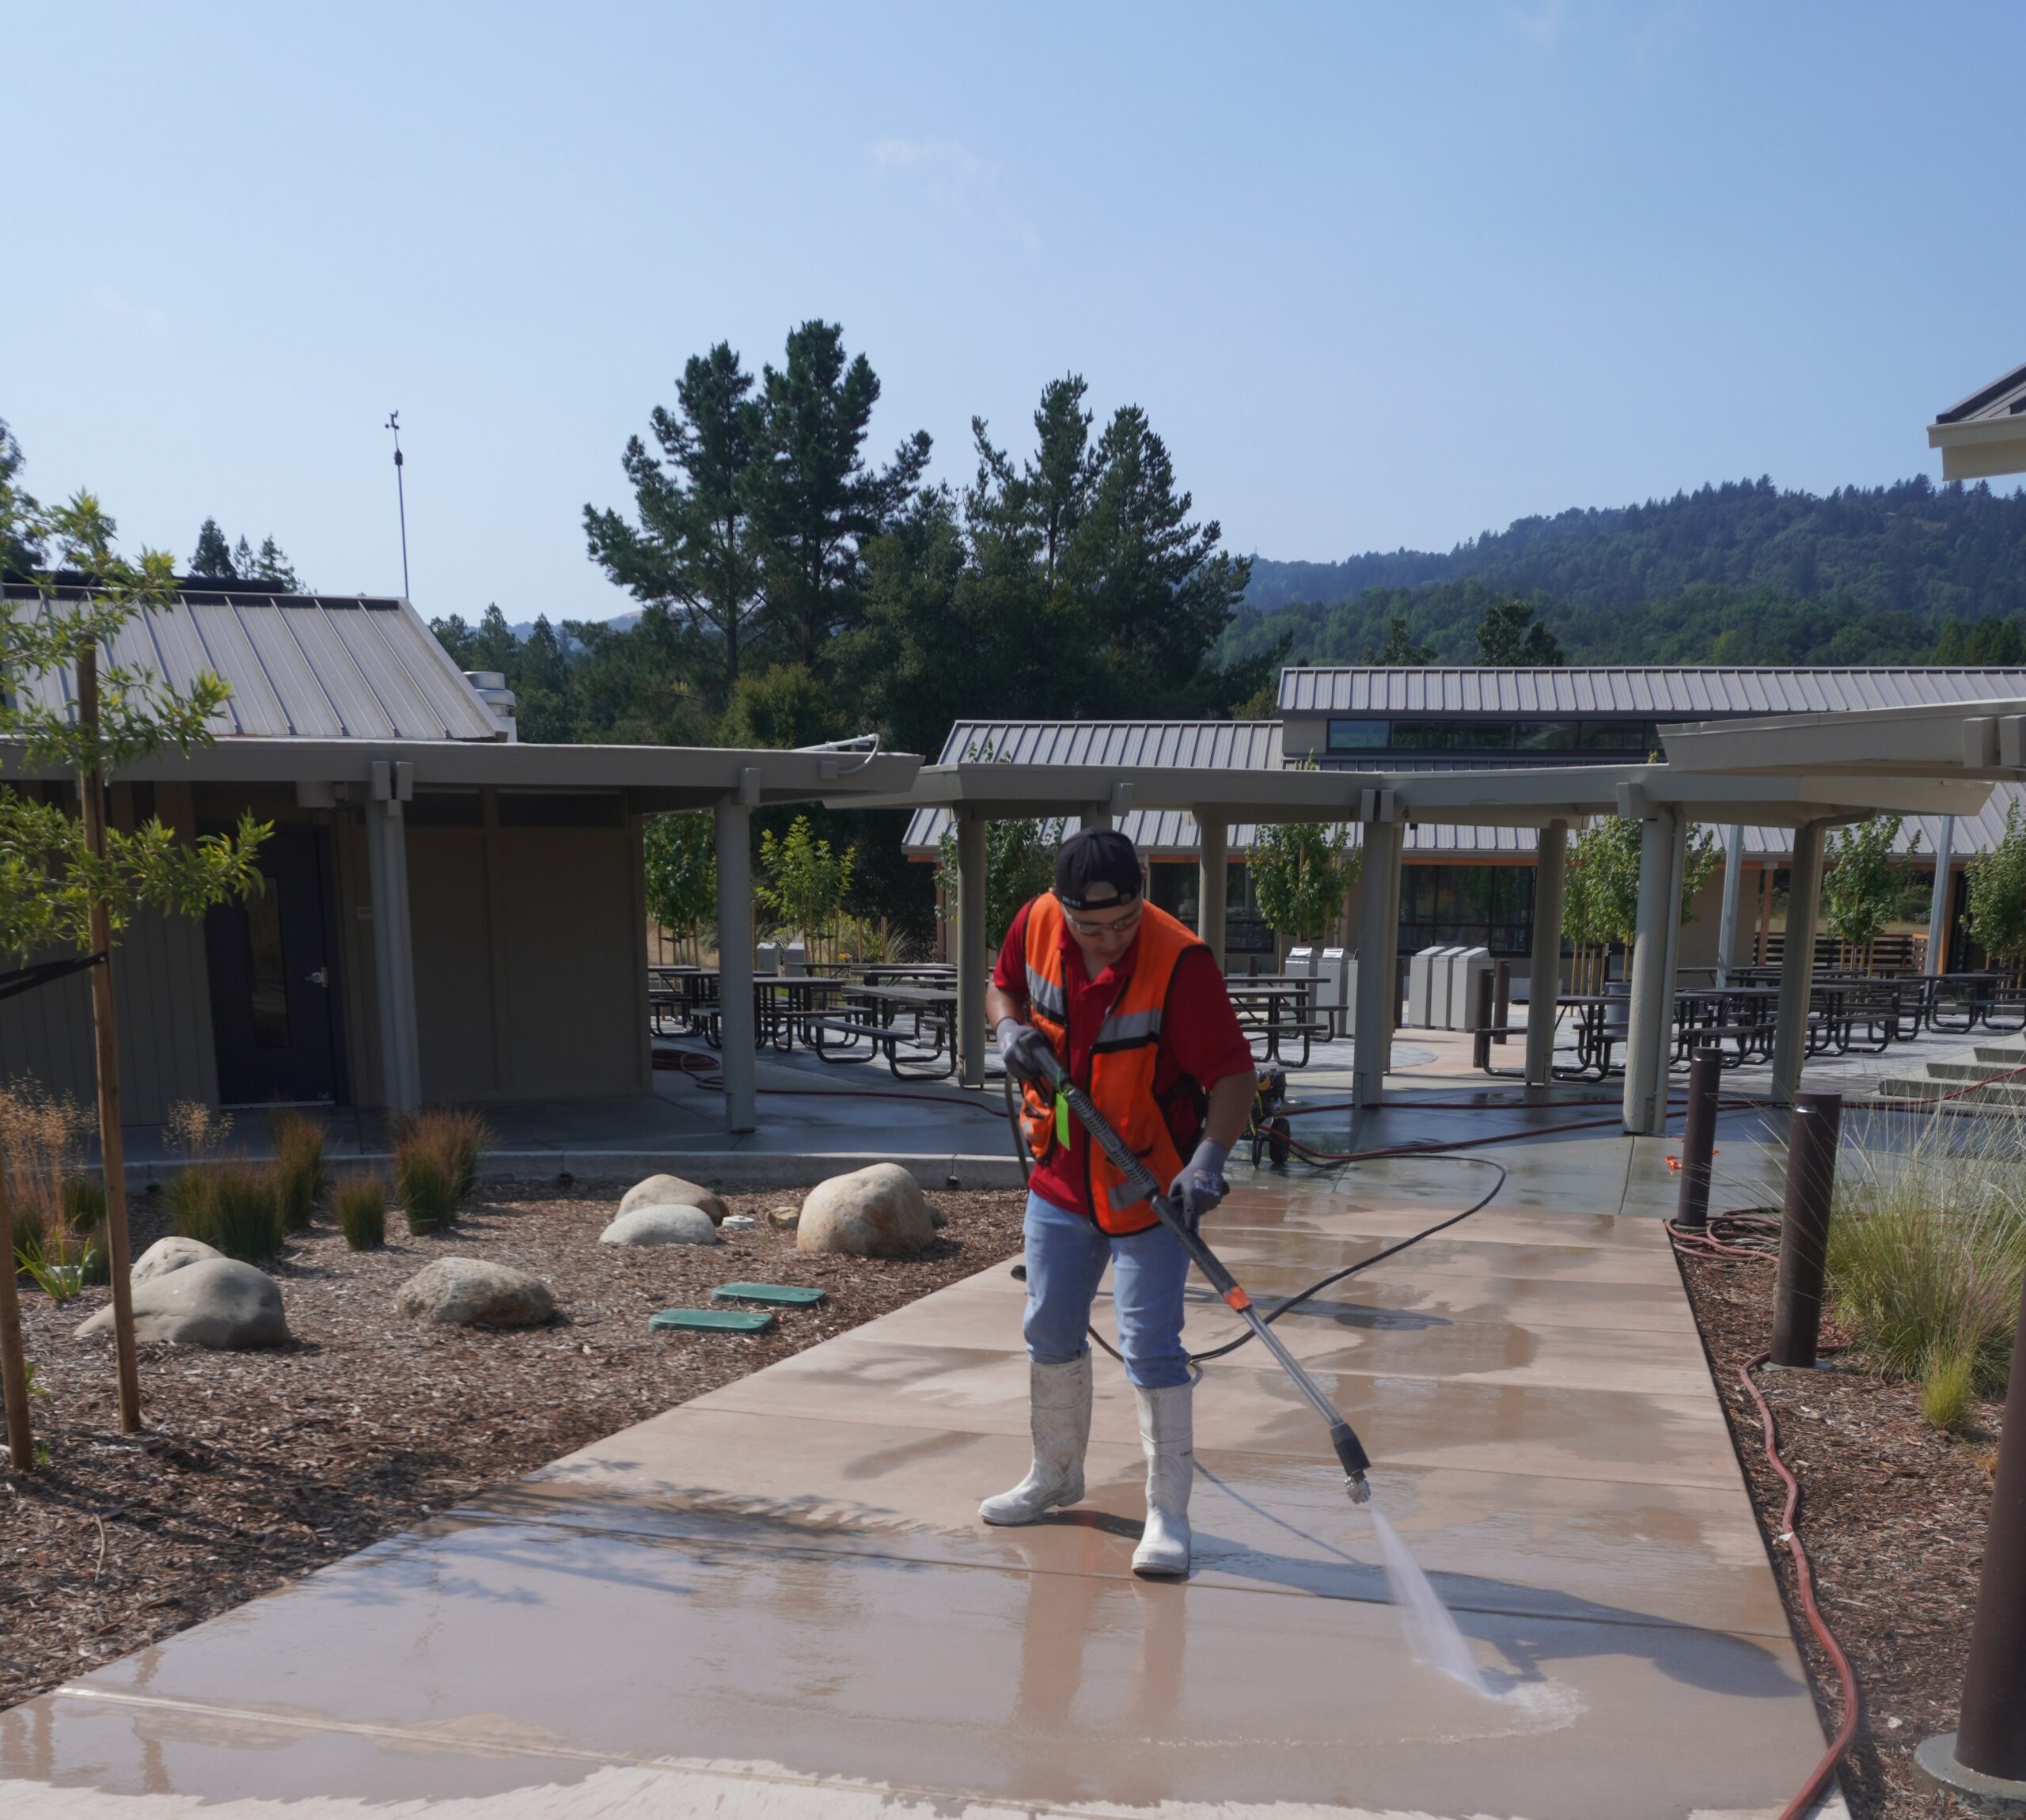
[{"xmin": 1023, "ymin": 892, "xmax": 1204, "ymax": 1236}]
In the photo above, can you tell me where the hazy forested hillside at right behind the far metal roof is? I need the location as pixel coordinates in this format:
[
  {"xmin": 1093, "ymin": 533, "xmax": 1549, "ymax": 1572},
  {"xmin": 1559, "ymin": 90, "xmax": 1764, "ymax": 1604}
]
[{"xmin": 1220, "ymin": 476, "xmax": 2026, "ymax": 663}]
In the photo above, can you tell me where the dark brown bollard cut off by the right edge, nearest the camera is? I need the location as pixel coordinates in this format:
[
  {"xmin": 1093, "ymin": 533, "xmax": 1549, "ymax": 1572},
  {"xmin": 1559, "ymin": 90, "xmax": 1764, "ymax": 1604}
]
[{"xmin": 1914, "ymin": 1256, "xmax": 2026, "ymax": 1802}]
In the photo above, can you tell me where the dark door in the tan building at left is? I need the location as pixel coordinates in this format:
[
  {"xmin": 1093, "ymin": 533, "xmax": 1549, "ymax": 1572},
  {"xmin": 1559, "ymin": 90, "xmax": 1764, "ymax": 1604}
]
[{"xmin": 205, "ymin": 827, "xmax": 340, "ymax": 1106}]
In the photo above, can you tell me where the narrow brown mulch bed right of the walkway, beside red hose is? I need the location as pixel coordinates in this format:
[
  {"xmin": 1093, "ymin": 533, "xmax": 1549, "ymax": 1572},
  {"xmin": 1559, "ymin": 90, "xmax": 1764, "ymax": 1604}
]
[{"xmin": 1682, "ymin": 1257, "xmax": 2001, "ymax": 1820}]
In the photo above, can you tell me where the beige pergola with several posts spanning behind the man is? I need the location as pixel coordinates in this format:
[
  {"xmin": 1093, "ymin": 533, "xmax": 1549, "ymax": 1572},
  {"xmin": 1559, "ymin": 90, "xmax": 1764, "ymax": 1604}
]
[{"xmin": 839, "ymin": 760, "xmax": 1990, "ymax": 1133}]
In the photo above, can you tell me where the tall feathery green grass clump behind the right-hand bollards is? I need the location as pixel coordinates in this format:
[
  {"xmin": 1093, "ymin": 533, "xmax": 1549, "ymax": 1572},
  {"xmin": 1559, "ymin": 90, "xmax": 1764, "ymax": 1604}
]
[{"xmin": 1830, "ymin": 1111, "xmax": 2026, "ymax": 1431}]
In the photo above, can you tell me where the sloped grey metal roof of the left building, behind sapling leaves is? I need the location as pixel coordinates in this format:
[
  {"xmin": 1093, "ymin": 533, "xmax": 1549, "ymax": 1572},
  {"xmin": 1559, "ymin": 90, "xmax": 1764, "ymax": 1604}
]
[{"xmin": 6, "ymin": 584, "xmax": 503, "ymax": 740}]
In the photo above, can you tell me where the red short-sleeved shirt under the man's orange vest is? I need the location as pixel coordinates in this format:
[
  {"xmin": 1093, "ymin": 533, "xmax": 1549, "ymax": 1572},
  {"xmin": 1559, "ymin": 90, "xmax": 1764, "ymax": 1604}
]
[{"xmin": 992, "ymin": 904, "xmax": 1254, "ymax": 1216}]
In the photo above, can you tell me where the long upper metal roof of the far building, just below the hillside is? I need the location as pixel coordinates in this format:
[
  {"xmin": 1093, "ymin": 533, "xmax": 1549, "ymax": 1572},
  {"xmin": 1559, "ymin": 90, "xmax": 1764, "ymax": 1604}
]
[{"xmin": 1278, "ymin": 665, "xmax": 2026, "ymax": 719}]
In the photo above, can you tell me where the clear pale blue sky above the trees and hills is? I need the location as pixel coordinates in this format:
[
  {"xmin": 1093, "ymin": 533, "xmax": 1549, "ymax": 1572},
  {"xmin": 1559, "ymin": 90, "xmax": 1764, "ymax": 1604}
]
[{"xmin": 0, "ymin": 0, "xmax": 2026, "ymax": 620}]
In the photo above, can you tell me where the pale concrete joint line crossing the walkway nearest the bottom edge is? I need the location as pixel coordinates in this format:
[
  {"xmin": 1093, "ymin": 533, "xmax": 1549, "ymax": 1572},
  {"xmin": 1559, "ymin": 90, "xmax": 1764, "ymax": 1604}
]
[{"xmin": 39, "ymin": 1682, "xmax": 1564, "ymax": 1820}]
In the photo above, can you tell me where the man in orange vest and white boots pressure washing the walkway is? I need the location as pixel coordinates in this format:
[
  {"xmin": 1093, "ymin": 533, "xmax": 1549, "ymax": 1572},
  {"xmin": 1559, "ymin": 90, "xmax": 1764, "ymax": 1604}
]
[{"xmin": 978, "ymin": 829, "xmax": 1254, "ymax": 1579}]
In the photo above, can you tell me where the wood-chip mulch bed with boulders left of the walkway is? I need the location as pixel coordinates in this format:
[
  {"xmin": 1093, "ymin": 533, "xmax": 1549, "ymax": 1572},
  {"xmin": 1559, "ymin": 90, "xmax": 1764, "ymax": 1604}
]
[{"xmin": 0, "ymin": 1184, "xmax": 1025, "ymax": 1708}]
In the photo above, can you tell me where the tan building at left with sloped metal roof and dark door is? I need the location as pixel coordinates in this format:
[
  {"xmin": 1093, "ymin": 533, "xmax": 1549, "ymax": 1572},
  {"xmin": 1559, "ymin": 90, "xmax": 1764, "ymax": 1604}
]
[{"xmin": 0, "ymin": 588, "xmax": 920, "ymax": 1131}]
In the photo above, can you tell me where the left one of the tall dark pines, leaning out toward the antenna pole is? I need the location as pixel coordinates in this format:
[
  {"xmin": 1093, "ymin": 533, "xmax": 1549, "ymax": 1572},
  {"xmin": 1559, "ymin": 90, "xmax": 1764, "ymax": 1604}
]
[{"xmin": 583, "ymin": 340, "xmax": 764, "ymax": 701}]
